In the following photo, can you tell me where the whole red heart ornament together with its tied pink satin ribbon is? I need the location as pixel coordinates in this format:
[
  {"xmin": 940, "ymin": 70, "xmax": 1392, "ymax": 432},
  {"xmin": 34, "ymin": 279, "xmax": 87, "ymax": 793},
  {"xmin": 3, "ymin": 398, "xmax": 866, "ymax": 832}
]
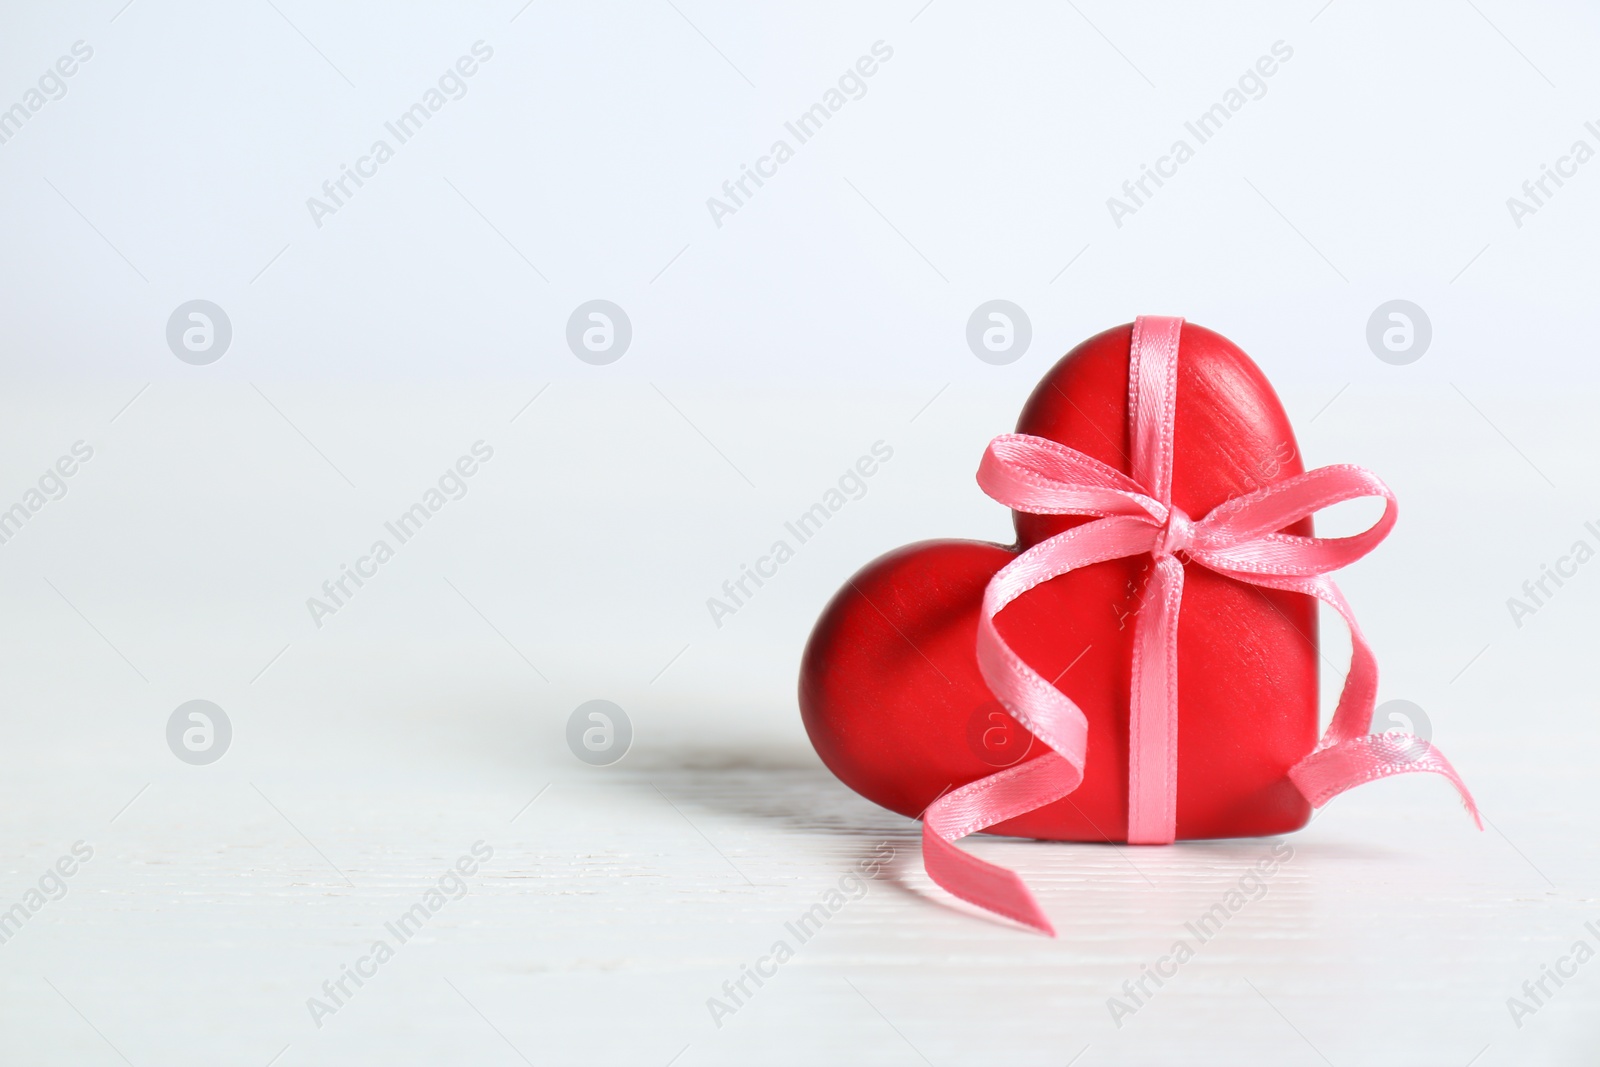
[{"xmin": 800, "ymin": 318, "xmax": 1482, "ymax": 933}]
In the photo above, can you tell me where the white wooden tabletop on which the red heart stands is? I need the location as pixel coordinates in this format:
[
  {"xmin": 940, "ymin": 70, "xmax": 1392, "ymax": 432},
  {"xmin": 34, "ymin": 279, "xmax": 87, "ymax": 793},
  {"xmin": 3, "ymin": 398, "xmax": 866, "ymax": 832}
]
[{"xmin": 0, "ymin": 384, "xmax": 1580, "ymax": 1067}]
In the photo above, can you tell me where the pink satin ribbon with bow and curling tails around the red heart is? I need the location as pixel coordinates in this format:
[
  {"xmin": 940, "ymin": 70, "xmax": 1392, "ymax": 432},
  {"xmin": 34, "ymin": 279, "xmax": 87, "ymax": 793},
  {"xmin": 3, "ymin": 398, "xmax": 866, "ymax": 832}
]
[{"xmin": 922, "ymin": 317, "xmax": 1483, "ymax": 936}]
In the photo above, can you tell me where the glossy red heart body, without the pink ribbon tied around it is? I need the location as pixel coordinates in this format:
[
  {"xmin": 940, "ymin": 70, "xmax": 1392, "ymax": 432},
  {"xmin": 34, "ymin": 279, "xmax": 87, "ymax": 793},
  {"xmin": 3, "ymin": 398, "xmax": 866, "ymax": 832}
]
[{"xmin": 800, "ymin": 323, "xmax": 1318, "ymax": 841}]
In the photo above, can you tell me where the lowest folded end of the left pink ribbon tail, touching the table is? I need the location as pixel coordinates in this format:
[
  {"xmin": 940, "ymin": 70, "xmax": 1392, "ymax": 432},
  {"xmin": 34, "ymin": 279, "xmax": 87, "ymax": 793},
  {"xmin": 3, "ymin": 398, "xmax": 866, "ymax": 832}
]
[{"xmin": 922, "ymin": 752, "xmax": 1083, "ymax": 937}]
